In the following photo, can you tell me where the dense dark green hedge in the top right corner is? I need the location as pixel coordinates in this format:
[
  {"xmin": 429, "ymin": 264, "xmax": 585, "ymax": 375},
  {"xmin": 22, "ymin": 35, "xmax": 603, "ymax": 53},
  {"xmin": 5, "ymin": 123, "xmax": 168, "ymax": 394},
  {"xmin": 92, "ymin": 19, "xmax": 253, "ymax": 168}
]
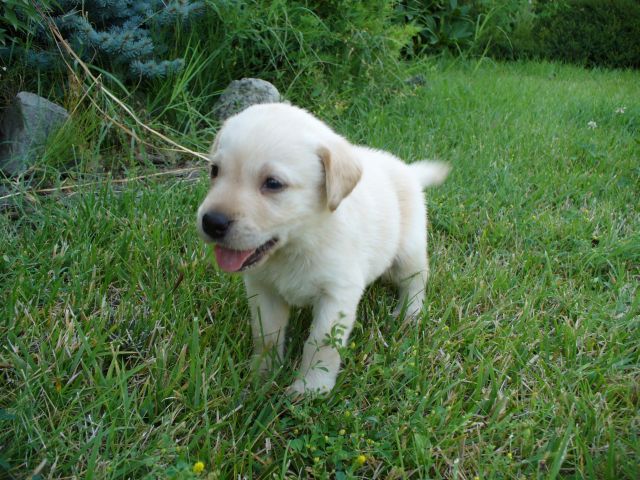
[{"xmin": 534, "ymin": 0, "xmax": 640, "ymax": 68}]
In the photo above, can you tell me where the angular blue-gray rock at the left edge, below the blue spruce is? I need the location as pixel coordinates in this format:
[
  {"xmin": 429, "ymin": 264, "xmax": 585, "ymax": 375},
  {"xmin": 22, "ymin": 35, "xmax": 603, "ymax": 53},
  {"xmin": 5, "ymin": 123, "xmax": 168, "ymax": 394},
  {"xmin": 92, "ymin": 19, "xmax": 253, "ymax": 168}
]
[{"xmin": 0, "ymin": 92, "xmax": 69, "ymax": 176}]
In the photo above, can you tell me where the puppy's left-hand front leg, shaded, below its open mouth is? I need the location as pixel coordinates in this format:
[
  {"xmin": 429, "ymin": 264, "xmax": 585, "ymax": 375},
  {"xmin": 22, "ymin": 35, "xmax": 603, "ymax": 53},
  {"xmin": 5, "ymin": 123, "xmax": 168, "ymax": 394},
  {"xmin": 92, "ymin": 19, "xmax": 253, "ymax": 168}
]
[{"xmin": 245, "ymin": 276, "xmax": 289, "ymax": 373}]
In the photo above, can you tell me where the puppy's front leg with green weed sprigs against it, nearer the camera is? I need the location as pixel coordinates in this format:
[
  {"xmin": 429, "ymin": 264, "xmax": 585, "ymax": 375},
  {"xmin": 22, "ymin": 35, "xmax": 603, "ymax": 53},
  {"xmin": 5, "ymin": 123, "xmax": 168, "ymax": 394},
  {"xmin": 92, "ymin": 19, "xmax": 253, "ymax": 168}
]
[{"xmin": 289, "ymin": 290, "xmax": 362, "ymax": 394}]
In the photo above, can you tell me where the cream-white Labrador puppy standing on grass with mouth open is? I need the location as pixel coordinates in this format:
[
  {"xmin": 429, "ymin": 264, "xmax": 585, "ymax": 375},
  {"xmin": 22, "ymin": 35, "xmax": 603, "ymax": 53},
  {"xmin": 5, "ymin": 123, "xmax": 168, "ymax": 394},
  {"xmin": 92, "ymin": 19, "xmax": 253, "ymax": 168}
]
[{"xmin": 197, "ymin": 103, "xmax": 449, "ymax": 394}]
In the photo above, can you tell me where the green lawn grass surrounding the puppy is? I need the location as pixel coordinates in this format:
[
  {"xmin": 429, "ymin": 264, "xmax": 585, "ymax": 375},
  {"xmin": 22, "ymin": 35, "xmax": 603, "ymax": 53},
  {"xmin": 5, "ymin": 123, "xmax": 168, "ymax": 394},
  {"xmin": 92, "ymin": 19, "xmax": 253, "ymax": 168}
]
[{"xmin": 0, "ymin": 63, "xmax": 640, "ymax": 479}]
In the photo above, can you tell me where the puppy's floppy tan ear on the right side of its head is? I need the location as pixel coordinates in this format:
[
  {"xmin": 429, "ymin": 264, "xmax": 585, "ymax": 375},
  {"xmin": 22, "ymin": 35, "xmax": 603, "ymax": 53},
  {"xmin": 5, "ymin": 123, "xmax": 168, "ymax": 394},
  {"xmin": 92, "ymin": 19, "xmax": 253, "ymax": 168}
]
[{"xmin": 318, "ymin": 142, "xmax": 362, "ymax": 212}]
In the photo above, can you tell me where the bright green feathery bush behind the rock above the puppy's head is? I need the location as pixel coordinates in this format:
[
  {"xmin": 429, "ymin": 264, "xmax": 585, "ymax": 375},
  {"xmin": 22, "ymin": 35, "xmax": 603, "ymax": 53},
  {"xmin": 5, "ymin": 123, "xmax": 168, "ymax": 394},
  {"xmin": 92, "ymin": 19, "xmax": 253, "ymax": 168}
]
[{"xmin": 146, "ymin": 0, "xmax": 415, "ymax": 120}]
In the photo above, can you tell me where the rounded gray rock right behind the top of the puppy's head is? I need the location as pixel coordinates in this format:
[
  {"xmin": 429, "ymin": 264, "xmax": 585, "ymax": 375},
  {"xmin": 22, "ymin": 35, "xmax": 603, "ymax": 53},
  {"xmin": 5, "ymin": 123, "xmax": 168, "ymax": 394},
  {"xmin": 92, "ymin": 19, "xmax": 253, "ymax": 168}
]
[{"xmin": 213, "ymin": 78, "xmax": 282, "ymax": 122}]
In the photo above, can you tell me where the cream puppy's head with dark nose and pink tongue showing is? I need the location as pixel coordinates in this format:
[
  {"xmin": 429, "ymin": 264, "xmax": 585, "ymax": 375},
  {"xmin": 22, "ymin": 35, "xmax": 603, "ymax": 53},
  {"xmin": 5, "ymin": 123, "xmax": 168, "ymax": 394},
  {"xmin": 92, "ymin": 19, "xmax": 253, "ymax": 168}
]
[{"xmin": 197, "ymin": 103, "xmax": 362, "ymax": 272}]
